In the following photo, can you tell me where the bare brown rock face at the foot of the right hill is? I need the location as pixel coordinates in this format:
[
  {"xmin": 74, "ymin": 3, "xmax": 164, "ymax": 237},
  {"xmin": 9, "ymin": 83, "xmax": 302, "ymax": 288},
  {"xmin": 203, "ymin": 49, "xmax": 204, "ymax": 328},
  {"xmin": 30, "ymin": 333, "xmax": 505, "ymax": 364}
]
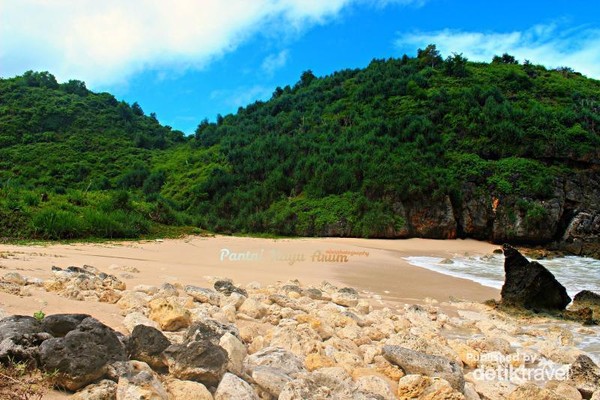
[{"xmin": 314, "ymin": 169, "xmax": 600, "ymax": 258}]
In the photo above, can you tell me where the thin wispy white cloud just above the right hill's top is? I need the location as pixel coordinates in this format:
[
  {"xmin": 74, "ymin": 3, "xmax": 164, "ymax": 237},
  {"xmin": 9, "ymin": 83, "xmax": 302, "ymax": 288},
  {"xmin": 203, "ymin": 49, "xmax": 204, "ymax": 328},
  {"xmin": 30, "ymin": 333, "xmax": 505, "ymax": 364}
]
[{"xmin": 396, "ymin": 24, "xmax": 600, "ymax": 79}]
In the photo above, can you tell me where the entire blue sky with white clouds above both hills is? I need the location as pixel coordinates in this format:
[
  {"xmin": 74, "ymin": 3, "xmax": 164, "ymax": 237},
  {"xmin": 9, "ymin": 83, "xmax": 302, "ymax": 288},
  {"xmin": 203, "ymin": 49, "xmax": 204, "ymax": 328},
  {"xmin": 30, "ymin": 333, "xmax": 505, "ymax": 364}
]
[{"xmin": 0, "ymin": 0, "xmax": 600, "ymax": 134}]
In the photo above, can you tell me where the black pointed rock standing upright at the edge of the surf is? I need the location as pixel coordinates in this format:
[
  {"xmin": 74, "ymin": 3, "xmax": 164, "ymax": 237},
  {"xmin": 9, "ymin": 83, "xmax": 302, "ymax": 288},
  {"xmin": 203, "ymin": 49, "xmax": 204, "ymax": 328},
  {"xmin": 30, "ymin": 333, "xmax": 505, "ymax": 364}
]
[{"xmin": 501, "ymin": 244, "xmax": 571, "ymax": 311}]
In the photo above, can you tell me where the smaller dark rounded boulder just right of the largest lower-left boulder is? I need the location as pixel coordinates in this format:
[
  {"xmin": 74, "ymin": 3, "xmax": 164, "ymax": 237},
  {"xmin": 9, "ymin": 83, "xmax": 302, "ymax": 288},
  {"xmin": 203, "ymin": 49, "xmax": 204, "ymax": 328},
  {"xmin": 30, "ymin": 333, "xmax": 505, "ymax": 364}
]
[{"xmin": 128, "ymin": 325, "xmax": 171, "ymax": 369}]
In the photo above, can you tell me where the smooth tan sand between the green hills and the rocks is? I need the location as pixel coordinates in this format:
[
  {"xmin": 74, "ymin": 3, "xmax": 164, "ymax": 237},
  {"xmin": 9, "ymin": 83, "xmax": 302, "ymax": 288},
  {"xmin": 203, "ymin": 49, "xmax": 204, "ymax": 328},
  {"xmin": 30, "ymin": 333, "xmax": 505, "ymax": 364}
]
[{"xmin": 0, "ymin": 236, "xmax": 499, "ymax": 330}]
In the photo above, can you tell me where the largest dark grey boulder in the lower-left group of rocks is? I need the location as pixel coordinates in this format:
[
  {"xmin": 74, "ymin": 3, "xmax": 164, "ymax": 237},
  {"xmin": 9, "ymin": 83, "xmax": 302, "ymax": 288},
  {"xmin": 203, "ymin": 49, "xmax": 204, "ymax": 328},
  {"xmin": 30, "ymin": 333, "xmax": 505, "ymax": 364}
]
[{"xmin": 39, "ymin": 317, "xmax": 127, "ymax": 391}]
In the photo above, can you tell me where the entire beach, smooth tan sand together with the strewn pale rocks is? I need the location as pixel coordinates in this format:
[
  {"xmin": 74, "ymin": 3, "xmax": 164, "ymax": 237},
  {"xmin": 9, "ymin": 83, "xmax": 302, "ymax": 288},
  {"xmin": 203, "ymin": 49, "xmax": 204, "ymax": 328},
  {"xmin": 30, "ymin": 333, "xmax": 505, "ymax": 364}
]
[{"xmin": 0, "ymin": 236, "xmax": 600, "ymax": 400}]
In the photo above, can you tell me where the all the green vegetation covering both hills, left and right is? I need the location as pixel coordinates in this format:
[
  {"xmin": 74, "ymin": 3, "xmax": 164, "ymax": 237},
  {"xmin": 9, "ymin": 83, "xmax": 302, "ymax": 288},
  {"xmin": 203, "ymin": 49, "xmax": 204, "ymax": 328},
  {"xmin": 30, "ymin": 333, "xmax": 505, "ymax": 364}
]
[{"xmin": 0, "ymin": 46, "xmax": 600, "ymax": 238}]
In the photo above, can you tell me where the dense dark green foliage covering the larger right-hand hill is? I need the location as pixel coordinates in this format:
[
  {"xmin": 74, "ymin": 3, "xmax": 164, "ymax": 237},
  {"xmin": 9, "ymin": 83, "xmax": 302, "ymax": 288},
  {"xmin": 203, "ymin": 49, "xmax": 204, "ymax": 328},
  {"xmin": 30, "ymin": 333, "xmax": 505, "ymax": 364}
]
[{"xmin": 193, "ymin": 47, "xmax": 600, "ymax": 236}]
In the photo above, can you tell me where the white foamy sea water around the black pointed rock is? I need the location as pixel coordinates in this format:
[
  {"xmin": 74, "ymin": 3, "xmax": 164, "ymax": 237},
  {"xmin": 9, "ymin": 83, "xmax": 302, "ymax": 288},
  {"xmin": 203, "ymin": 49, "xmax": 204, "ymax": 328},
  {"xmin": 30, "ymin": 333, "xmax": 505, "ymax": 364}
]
[{"xmin": 404, "ymin": 254, "xmax": 600, "ymax": 364}]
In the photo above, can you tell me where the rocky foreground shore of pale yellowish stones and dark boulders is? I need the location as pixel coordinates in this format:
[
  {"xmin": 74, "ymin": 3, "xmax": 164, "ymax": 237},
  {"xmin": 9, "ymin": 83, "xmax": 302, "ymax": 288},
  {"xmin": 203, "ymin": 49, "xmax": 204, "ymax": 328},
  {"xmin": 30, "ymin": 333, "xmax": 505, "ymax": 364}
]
[{"xmin": 0, "ymin": 255, "xmax": 600, "ymax": 400}]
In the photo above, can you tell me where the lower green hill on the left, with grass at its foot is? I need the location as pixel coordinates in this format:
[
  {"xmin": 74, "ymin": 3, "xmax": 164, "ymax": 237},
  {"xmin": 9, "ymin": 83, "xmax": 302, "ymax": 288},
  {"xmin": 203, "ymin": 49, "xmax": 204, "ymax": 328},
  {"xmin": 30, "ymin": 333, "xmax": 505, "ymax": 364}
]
[{"xmin": 0, "ymin": 71, "xmax": 188, "ymax": 239}]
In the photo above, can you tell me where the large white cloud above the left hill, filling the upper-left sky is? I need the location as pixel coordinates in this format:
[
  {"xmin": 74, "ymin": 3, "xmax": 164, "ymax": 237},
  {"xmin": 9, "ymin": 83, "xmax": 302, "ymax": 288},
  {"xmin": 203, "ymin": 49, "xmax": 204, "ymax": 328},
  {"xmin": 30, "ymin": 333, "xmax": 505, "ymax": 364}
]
[{"xmin": 0, "ymin": 0, "xmax": 417, "ymax": 87}]
